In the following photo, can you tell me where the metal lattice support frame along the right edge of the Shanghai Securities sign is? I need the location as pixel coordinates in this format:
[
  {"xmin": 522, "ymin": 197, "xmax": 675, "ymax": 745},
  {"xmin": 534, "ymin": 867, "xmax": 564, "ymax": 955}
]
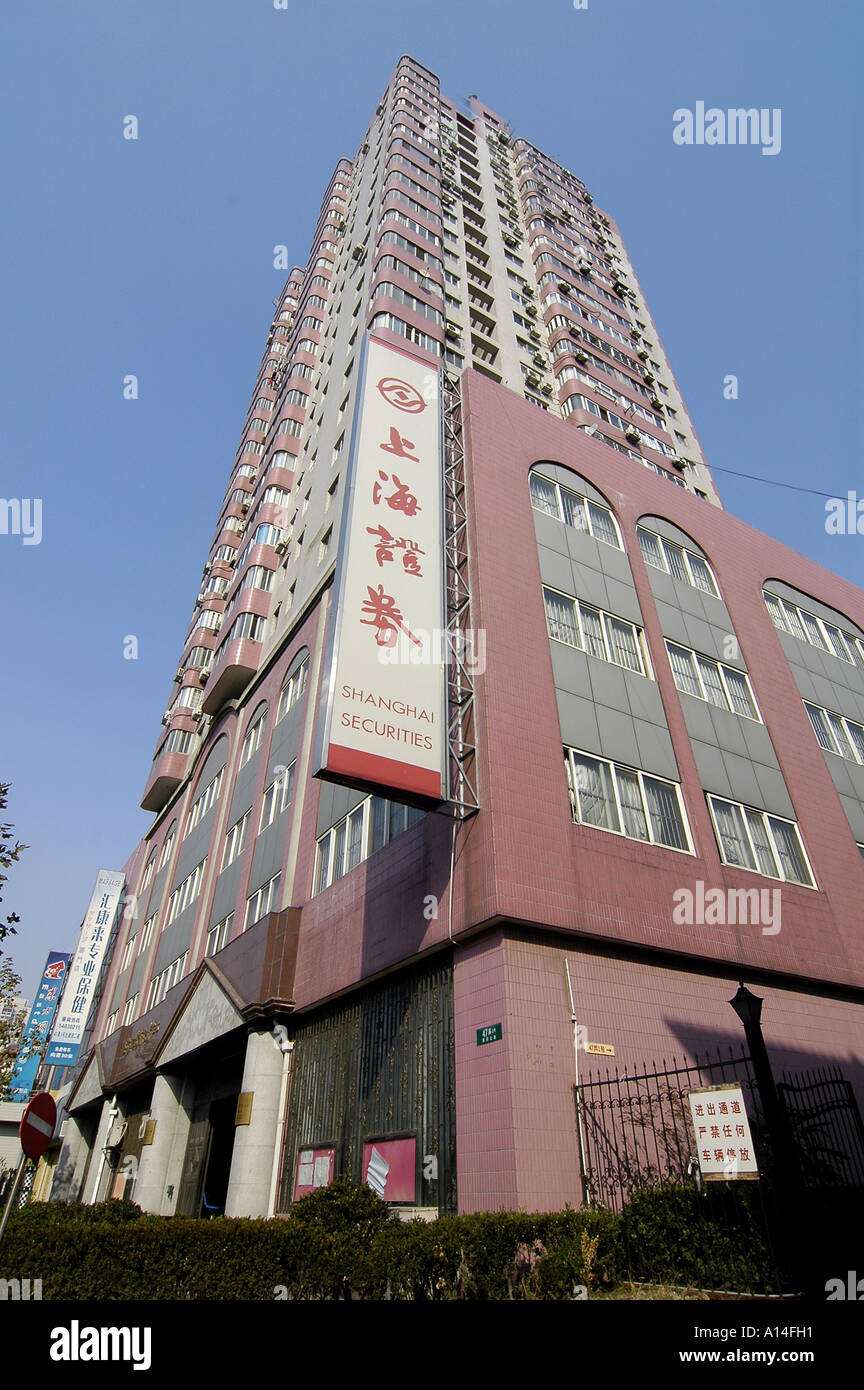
[{"xmin": 442, "ymin": 373, "xmax": 479, "ymax": 820}]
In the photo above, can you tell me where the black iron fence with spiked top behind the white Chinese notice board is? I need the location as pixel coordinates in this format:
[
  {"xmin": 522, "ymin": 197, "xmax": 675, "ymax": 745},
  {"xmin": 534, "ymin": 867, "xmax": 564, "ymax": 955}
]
[{"xmin": 575, "ymin": 1047, "xmax": 864, "ymax": 1294}]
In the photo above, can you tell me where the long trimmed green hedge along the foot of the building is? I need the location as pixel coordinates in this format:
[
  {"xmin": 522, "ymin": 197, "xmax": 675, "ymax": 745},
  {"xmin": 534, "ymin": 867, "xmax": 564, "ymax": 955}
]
[{"xmin": 0, "ymin": 1183, "xmax": 767, "ymax": 1300}]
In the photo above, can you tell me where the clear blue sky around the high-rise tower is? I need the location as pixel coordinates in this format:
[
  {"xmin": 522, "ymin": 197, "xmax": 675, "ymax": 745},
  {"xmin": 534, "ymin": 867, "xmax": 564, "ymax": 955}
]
[{"xmin": 0, "ymin": 0, "xmax": 864, "ymax": 997}]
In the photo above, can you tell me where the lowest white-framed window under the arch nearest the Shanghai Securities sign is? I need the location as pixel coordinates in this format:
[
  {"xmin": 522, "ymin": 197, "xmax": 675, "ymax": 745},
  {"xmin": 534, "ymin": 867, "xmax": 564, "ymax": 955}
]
[{"xmin": 564, "ymin": 748, "xmax": 692, "ymax": 853}]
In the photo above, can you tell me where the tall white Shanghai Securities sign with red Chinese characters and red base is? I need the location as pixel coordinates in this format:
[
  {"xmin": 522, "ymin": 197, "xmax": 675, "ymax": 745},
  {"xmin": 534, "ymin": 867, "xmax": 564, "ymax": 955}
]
[{"xmin": 317, "ymin": 336, "xmax": 447, "ymax": 801}]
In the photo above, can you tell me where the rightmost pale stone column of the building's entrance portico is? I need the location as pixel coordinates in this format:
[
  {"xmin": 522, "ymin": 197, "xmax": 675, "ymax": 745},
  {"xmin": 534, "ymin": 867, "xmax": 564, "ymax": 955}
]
[{"xmin": 225, "ymin": 1030, "xmax": 288, "ymax": 1216}]
